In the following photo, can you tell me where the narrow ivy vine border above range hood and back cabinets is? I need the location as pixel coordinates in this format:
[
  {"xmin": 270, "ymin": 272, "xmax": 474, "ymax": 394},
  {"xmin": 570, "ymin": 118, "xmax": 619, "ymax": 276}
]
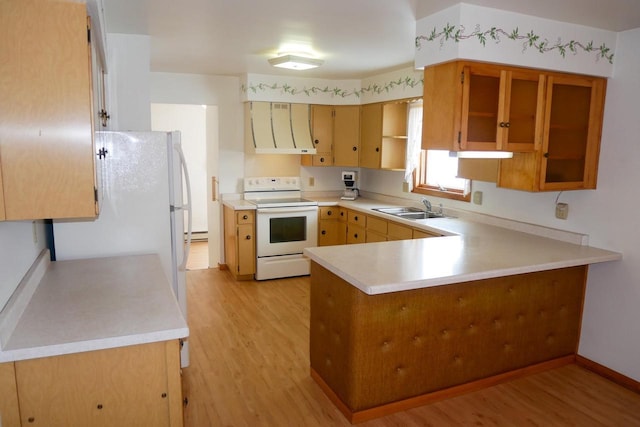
[{"xmin": 241, "ymin": 76, "xmax": 424, "ymax": 98}]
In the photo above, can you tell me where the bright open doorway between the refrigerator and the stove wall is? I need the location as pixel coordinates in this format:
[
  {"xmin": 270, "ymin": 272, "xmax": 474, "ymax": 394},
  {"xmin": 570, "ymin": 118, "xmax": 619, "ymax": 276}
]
[{"xmin": 151, "ymin": 103, "xmax": 220, "ymax": 269}]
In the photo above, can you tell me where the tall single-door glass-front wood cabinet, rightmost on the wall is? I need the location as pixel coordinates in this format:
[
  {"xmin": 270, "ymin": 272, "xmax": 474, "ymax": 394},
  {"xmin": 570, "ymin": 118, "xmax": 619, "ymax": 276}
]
[{"xmin": 498, "ymin": 74, "xmax": 606, "ymax": 191}]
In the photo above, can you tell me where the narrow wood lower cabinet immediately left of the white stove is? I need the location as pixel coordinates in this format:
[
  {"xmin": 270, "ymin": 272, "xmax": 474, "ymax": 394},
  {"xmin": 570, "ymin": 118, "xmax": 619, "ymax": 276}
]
[{"xmin": 223, "ymin": 206, "xmax": 256, "ymax": 280}]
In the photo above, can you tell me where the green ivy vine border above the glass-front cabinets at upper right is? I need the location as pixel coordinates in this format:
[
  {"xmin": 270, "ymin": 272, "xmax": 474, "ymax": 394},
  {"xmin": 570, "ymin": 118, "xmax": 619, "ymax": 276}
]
[{"xmin": 416, "ymin": 23, "xmax": 613, "ymax": 64}]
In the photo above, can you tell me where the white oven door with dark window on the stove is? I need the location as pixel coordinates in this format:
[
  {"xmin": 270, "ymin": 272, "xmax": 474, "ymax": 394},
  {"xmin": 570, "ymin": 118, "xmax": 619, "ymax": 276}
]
[{"xmin": 256, "ymin": 206, "xmax": 318, "ymax": 258}]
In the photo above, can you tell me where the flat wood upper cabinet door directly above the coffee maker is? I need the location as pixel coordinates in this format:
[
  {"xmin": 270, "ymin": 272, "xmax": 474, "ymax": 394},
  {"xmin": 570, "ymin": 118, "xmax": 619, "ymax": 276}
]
[{"xmin": 333, "ymin": 105, "xmax": 360, "ymax": 167}]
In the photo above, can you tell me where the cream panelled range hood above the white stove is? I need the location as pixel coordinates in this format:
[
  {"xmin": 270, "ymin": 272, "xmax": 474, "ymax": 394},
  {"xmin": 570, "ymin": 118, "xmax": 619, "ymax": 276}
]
[{"xmin": 244, "ymin": 101, "xmax": 316, "ymax": 154}]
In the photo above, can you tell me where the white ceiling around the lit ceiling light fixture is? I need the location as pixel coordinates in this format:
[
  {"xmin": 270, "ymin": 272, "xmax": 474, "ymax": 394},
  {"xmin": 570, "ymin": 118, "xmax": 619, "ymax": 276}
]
[{"xmin": 103, "ymin": 0, "xmax": 640, "ymax": 79}]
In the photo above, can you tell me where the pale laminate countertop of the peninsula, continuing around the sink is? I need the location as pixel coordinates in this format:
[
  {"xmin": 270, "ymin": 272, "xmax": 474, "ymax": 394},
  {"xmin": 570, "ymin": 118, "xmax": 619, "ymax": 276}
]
[{"xmin": 304, "ymin": 199, "xmax": 622, "ymax": 295}]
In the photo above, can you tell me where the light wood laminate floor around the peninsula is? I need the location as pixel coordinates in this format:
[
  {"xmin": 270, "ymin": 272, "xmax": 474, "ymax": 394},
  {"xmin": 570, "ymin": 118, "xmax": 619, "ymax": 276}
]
[{"xmin": 183, "ymin": 269, "xmax": 640, "ymax": 427}]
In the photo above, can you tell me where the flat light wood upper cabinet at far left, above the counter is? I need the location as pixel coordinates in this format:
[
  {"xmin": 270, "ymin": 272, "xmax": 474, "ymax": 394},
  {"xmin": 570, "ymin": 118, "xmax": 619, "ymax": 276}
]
[{"xmin": 0, "ymin": 0, "xmax": 97, "ymax": 220}]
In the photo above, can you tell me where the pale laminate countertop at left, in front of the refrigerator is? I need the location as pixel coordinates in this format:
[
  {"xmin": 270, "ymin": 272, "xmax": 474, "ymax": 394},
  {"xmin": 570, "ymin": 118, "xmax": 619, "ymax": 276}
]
[{"xmin": 0, "ymin": 255, "xmax": 189, "ymax": 362}]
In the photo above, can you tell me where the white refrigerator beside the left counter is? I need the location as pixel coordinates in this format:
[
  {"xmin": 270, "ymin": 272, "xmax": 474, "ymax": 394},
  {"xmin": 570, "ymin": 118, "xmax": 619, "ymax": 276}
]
[{"xmin": 53, "ymin": 132, "xmax": 191, "ymax": 367}]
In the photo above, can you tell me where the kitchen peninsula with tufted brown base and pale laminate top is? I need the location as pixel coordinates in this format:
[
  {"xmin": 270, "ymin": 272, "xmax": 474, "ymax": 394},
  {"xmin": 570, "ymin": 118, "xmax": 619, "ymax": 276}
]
[{"xmin": 305, "ymin": 208, "xmax": 621, "ymax": 423}]
